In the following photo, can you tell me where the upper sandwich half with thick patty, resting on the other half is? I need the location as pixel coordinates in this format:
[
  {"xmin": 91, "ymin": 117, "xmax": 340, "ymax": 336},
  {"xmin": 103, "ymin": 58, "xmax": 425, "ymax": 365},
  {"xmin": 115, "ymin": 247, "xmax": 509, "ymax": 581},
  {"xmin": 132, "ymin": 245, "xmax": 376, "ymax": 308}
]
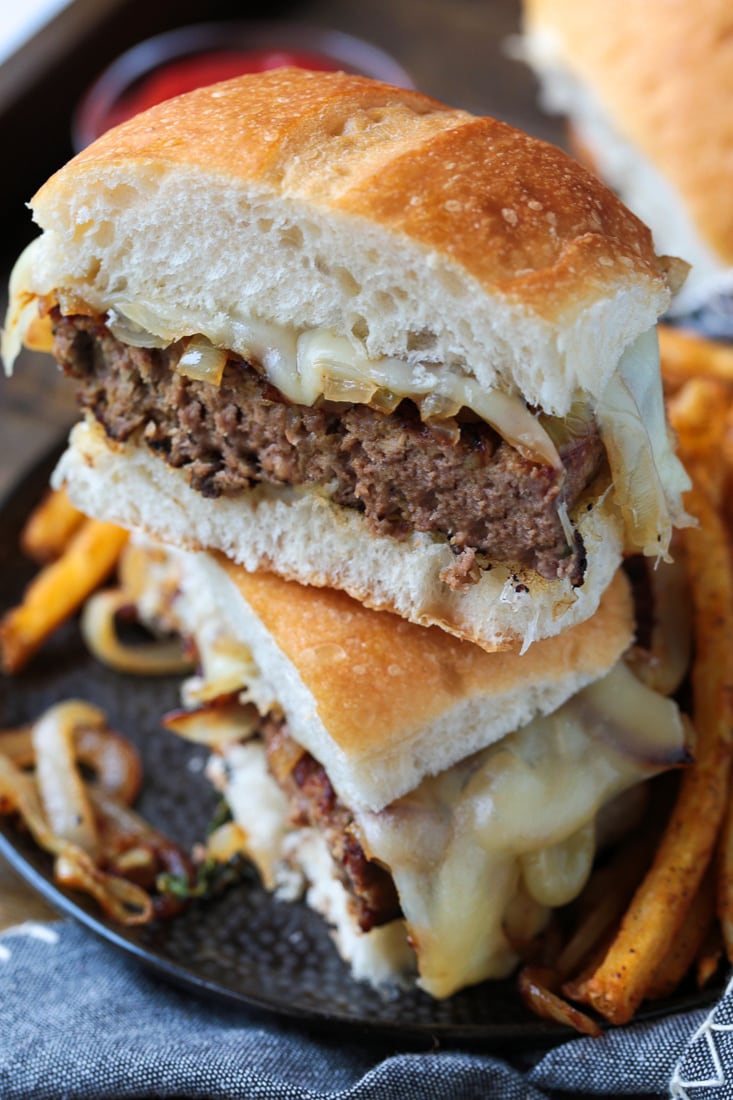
[{"xmin": 4, "ymin": 70, "xmax": 687, "ymax": 649}]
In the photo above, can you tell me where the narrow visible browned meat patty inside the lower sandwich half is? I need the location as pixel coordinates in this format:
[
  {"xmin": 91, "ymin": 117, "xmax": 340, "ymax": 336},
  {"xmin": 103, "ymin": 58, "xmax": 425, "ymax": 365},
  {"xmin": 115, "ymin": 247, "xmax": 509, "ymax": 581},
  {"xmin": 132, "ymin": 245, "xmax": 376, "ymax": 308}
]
[{"xmin": 263, "ymin": 719, "xmax": 401, "ymax": 932}]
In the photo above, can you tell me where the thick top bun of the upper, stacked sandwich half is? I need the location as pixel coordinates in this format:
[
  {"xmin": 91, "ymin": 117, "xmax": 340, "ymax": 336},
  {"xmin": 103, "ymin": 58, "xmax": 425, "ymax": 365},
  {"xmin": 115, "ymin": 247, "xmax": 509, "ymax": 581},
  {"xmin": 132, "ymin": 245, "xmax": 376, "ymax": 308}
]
[{"xmin": 25, "ymin": 69, "xmax": 669, "ymax": 416}]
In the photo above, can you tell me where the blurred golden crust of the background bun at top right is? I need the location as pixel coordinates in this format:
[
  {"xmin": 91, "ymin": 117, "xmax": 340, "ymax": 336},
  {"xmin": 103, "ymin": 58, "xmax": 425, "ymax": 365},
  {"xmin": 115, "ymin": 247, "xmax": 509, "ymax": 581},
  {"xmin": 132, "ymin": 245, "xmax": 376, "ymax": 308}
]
[{"xmin": 525, "ymin": 0, "xmax": 733, "ymax": 265}]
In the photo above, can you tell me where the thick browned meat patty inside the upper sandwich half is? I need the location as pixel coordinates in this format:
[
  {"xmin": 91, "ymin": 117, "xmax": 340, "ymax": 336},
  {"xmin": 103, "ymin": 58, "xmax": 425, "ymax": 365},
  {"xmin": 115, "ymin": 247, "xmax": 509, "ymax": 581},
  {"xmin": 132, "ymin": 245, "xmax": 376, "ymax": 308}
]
[{"xmin": 53, "ymin": 310, "xmax": 604, "ymax": 587}]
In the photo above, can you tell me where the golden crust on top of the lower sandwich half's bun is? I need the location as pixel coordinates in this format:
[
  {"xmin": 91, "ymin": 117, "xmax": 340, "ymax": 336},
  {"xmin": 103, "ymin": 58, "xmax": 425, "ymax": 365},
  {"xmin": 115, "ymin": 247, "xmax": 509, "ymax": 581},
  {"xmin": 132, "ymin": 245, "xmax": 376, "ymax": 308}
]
[{"xmin": 218, "ymin": 556, "xmax": 633, "ymax": 757}]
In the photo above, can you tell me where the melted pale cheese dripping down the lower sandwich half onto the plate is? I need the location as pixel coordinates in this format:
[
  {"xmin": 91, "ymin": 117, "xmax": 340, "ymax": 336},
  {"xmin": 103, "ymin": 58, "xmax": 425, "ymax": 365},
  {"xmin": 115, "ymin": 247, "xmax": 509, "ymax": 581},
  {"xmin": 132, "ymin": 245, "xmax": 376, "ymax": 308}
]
[{"xmin": 357, "ymin": 662, "xmax": 685, "ymax": 998}]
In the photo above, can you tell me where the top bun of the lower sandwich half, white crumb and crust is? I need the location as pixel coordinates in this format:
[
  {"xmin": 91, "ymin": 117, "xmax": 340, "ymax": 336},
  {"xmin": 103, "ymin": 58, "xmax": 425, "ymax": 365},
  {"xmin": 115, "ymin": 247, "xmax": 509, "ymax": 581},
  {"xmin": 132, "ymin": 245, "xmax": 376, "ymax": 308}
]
[{"xmin": 134, "ymin": 548, "xmax": 634, "ymax": 810}]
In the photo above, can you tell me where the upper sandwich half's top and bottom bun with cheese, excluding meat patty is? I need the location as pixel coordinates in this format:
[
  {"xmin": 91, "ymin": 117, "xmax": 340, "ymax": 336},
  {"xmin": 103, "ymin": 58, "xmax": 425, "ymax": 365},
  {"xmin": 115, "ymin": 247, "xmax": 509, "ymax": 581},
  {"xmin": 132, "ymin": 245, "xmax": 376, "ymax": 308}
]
[{"xmin": 6, "ymin": 70, "xmax": 687, "ymax": 649}]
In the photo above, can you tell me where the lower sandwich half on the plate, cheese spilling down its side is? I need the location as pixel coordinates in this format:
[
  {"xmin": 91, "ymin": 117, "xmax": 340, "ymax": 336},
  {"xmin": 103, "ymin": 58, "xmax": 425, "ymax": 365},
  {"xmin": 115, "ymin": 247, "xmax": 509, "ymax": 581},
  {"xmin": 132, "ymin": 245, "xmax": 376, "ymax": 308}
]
[{"xmin": 108, "ymin": 546, "xmax": 685, "ymax": 998}]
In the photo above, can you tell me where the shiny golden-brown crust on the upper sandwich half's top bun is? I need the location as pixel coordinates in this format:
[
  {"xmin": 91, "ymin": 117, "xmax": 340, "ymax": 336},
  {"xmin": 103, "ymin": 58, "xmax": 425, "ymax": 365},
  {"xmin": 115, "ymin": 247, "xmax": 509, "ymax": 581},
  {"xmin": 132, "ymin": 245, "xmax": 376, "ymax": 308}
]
[{"xmin": 32, "ymin": 69, "xmax": 664, "ymax": 319}]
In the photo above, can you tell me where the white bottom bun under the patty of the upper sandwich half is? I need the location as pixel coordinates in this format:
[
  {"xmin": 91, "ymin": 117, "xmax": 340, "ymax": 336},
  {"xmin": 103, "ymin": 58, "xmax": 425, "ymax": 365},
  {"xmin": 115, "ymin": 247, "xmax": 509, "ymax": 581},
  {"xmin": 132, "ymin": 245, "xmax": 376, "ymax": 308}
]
[{"xmin": 54, "ymin": 420, "xmax": 622, "ymax": 650}]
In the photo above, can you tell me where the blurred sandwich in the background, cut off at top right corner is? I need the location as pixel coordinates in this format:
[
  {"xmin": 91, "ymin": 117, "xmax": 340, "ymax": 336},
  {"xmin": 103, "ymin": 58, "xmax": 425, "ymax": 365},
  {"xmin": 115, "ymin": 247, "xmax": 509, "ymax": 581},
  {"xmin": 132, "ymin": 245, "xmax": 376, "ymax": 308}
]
[{"xmin": 524, "ymin": 0, "xmax": 733, "ymax": 319}]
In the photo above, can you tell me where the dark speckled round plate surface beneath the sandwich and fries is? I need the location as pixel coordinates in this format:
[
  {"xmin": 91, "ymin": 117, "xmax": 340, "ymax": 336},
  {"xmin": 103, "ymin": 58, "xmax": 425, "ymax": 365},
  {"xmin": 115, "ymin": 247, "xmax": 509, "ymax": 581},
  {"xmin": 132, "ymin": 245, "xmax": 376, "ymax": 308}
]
[{"xmin": 0, "ymin": 444, "xmax": 712, "ymax": 1045}]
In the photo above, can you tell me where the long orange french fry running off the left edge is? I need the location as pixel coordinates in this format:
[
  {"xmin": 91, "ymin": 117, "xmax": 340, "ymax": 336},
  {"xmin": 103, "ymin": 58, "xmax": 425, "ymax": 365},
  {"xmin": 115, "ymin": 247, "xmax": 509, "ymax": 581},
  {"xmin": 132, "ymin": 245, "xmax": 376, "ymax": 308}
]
[{"xmin": 0, "ymin": 519, "xmax": 128, "ymax": 674}]
